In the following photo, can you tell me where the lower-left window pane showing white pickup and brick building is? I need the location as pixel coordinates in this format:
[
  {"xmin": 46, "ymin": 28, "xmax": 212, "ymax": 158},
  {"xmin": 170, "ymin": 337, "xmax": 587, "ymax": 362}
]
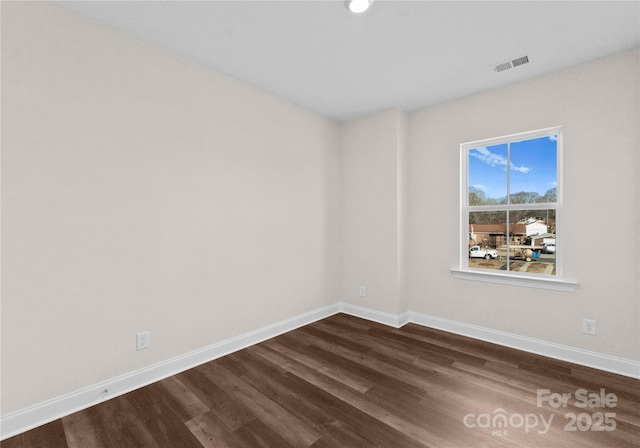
[{"xmin": 469, "ymin": 211, "xmax": 507, "ymax": 270}]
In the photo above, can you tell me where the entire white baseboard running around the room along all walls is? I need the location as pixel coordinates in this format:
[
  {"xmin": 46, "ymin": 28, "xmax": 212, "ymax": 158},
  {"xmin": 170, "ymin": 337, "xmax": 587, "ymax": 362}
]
[{"xmin": 0, "ymin": 302, "xmax": 640, "ymax": 440}]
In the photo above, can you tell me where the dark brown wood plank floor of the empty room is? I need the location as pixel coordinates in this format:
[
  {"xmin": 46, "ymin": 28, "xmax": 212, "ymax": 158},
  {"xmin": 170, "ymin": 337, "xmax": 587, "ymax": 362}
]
[{"xmin": 2, "ymin": 314, "xmax": 640, "ymax": 448}]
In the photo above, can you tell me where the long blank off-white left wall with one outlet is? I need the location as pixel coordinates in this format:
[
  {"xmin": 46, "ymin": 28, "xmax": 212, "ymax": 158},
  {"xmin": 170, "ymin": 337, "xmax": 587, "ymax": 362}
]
[{"xmin": 2, "ymin": 2, "xmax": 340, "ymax": 415}]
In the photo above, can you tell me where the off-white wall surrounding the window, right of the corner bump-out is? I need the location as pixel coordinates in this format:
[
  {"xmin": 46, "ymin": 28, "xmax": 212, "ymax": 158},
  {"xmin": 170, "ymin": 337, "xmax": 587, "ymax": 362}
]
[{"xmin": 408, "ymin": 50, "xmax": 640, "ymax": 361}]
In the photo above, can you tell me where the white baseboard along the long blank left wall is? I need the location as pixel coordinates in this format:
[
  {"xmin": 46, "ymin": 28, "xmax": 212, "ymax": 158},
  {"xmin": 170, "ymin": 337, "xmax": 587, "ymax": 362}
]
[{"xmin": 0, "ymin": 303, "xmax": 340, "ymax": 440}]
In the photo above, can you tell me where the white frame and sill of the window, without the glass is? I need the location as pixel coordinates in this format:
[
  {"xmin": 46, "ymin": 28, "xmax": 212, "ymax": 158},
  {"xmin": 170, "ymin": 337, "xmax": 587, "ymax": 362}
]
[{"xmin": 451, "ymin": 126, "xmax": 577, "ymax": 292}]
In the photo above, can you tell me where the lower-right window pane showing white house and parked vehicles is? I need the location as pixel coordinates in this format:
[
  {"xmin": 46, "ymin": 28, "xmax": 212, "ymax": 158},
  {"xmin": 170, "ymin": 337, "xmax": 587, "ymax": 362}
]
[{"xmin": 508, "ymin": 210, "xmax": 556, "ymax": 275}]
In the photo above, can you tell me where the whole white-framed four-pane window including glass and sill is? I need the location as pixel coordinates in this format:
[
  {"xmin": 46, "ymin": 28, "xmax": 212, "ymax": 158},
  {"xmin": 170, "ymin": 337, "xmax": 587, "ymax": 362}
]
[{"xmin": 454, "ymin": 128, "xmax": 575, "ymax": 290}]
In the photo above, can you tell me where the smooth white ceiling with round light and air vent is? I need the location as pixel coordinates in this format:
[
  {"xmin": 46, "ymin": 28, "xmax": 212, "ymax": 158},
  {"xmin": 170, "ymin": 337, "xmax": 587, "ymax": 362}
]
[{"xmin": 59, "ymin": 0, "xmax": 640, "ymax": 120}]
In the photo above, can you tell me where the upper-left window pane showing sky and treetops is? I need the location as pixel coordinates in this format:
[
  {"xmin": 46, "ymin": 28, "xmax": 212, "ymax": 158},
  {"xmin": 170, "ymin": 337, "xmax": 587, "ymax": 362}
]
[{"xmin": 467, "ymin": 143, "xmax": 508, "ymax": 206}]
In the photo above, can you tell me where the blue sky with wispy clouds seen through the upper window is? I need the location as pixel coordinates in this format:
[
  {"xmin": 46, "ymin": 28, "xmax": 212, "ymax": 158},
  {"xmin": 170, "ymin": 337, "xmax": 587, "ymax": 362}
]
[{"xmin": 469, "ymin": 136, "xmax": 558, "ymax": 199}]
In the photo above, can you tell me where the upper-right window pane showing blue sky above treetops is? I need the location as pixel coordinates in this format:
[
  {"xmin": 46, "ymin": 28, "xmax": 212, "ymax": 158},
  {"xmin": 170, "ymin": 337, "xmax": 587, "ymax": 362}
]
[{"xmin": 509, "ymin": 135, "xmax": 558, "ymax": 204}]
